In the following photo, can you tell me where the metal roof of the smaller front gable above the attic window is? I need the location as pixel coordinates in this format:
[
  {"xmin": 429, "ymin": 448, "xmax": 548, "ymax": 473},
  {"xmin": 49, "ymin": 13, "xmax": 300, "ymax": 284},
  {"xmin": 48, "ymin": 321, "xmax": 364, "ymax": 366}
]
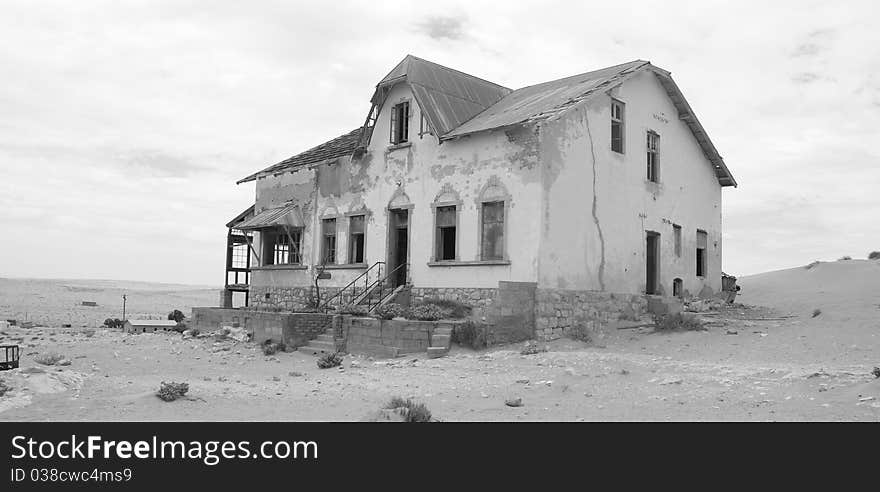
[{"xmin": 371, "ymin": 55, "xmax": 511, "ymax": 135}]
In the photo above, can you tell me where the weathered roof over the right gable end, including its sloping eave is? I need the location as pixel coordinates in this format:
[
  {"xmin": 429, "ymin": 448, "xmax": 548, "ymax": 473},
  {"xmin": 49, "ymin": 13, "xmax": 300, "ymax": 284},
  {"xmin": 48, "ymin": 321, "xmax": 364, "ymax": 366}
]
[{"xmin": 440, "ymin": 60, "xmax": 736, "ymax": 186}]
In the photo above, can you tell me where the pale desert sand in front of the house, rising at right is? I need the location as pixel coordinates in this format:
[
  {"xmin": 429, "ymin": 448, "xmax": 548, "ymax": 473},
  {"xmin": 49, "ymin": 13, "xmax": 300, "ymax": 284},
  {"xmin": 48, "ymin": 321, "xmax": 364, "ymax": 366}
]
[{"xmin": 0, "ymin": 260, "xmax": 880, "ymax": 421}]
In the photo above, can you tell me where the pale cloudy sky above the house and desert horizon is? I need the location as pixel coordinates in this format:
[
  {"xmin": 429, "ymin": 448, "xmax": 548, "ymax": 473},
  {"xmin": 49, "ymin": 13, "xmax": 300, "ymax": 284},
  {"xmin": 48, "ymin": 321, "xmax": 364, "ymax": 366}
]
[{"xmin": 0, "ymin": 0, "xmax": 880, "ymax": 286}]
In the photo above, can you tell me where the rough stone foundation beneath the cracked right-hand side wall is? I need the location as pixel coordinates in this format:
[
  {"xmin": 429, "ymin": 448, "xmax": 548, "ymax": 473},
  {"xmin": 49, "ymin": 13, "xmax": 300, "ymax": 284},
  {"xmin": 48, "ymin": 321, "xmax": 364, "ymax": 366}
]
[{"xmin": 535, "ymin": 289, "xmax": 647, "ymax": 340}]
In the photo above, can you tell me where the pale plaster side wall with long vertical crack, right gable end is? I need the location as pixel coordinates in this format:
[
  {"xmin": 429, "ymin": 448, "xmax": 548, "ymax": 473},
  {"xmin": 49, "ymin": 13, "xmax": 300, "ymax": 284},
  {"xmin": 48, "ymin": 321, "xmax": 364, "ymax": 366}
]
[{"xmin": 538, "ymin": 72, "xmax": 721, "ymax": 295}]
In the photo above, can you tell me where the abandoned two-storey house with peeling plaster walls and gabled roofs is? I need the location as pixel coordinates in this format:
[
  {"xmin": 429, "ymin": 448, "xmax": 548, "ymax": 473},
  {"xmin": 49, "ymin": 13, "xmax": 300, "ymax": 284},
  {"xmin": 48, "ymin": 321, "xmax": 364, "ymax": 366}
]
[{"xmin": 223, "ymin": 52, "xmax": 736, "ymax": 338}]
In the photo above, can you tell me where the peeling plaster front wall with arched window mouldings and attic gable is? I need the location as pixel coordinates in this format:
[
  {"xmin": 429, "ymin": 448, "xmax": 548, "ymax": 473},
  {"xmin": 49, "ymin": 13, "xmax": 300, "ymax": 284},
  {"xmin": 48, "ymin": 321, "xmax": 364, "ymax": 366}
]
[{"xmin": 252, "ymin": 84, "xmax": 542, "ymax": 287}]
